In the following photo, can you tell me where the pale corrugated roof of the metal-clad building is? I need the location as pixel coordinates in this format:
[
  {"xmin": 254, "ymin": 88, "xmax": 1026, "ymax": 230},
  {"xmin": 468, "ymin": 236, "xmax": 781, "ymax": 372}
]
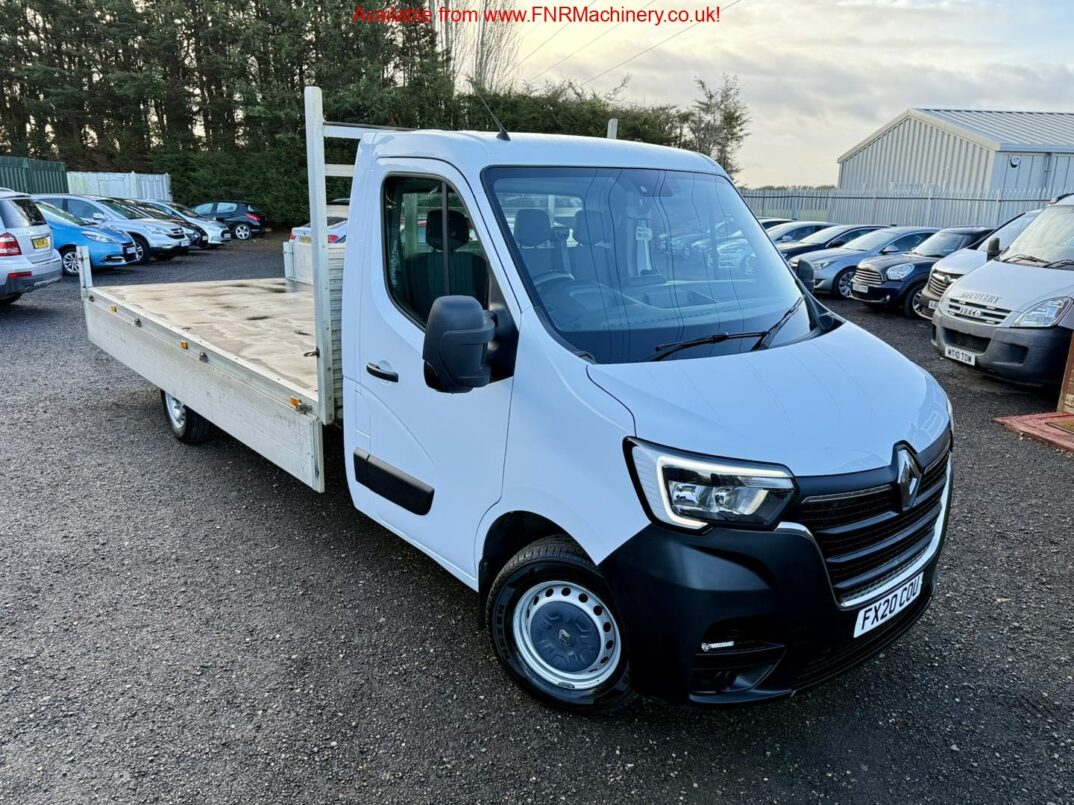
[{"xmin": 838, "ymin": 108, "xmax": 1074, "ymax": 162}]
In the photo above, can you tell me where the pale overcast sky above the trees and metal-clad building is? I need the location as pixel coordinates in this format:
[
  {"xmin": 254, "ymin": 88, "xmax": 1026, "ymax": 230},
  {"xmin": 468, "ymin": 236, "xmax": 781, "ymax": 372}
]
[{"xmin": 519, "ymin": 0, "xmax": 1074, "ymax": 186}]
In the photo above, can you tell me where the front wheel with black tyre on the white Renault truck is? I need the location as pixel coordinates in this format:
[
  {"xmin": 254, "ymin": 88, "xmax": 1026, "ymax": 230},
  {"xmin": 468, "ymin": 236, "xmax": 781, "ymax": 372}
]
[{"xmin": 485, "ymin": 536, "xmax": 637, "ymax": 714}]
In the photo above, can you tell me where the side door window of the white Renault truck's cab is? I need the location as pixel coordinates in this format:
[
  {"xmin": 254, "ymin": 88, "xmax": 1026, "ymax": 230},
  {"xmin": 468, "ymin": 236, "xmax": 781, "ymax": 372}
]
[{"xmin": 383, "ymin": 176, "xmax": 491, "ymax": 327}]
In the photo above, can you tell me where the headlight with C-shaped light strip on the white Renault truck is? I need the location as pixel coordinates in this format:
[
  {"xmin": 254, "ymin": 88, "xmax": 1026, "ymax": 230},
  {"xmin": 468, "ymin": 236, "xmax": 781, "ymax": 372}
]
[{"xmin": 627, "ymin": 442, "xmax": 795, "ymax": 530}]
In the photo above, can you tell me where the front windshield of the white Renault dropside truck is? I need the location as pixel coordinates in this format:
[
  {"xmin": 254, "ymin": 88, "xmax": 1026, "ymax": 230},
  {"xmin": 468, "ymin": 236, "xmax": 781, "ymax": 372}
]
[{"xmin": 484, "ymin": 167, "xmax": 811, "ymax": 363}]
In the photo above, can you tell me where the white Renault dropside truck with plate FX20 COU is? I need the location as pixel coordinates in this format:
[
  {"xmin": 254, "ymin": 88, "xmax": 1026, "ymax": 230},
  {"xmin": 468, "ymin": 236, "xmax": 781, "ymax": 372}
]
[{"xmin": 83, "ymin": 88, "xmax": 952, "ymax": 712}]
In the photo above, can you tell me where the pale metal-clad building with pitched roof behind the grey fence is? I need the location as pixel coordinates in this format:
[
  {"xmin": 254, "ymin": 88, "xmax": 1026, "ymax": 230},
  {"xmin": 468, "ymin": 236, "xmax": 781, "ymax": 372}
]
[{"xmin": 839, "ymin": 108, "xmax": 1074, "ymax": 196}]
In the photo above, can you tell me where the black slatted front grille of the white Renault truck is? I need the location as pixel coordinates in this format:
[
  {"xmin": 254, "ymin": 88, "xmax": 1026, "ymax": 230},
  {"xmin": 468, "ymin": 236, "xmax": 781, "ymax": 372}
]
[{"xmin": 793, "ymin": 450, "xmax": 949, "ymax": 602}]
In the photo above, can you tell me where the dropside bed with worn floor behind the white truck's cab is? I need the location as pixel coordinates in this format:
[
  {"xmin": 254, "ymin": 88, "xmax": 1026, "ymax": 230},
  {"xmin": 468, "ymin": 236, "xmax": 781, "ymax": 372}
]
[{"xmin": 82, "ymin": 244, "xmax": 343, "ymax": 492}]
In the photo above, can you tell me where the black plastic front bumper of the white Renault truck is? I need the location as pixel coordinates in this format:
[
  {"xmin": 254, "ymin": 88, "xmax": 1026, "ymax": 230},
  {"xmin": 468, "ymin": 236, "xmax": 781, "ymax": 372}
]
[{"xmin": 600, "ymin": 437, "xmax": 952, "ymax": 704}]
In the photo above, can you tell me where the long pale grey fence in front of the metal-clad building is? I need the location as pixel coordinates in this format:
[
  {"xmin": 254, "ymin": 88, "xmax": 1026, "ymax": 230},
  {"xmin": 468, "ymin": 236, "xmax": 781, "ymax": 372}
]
[{"xmin": 742, "ymin": 187, "xmax": 1056, "ymax": 226}]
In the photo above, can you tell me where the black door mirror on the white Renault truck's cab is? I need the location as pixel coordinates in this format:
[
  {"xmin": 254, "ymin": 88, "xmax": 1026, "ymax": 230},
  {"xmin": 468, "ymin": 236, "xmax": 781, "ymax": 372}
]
[{"xmin": 422, "ymin": 296, "xmax": 495, "ymax": 394}]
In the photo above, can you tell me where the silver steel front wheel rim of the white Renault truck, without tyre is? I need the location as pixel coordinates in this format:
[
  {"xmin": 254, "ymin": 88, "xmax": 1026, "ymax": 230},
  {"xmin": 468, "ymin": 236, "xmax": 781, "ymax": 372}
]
[{"xmin": 511, "ymin": 581, "xmax": 622, "ymax": 690}]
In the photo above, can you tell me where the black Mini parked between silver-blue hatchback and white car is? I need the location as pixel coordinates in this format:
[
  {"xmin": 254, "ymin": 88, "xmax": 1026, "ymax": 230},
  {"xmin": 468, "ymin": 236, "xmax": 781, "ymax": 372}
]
[{"xmin": 851, "ymin": 226, "xmax": 991, "ymax": 319}]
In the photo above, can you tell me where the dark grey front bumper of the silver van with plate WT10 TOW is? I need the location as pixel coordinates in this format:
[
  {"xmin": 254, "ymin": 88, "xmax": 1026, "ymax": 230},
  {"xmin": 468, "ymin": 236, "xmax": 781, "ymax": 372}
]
[{"xmin": 932, "ymin": 310, "xmax": 1071, "ymax": 385}]
